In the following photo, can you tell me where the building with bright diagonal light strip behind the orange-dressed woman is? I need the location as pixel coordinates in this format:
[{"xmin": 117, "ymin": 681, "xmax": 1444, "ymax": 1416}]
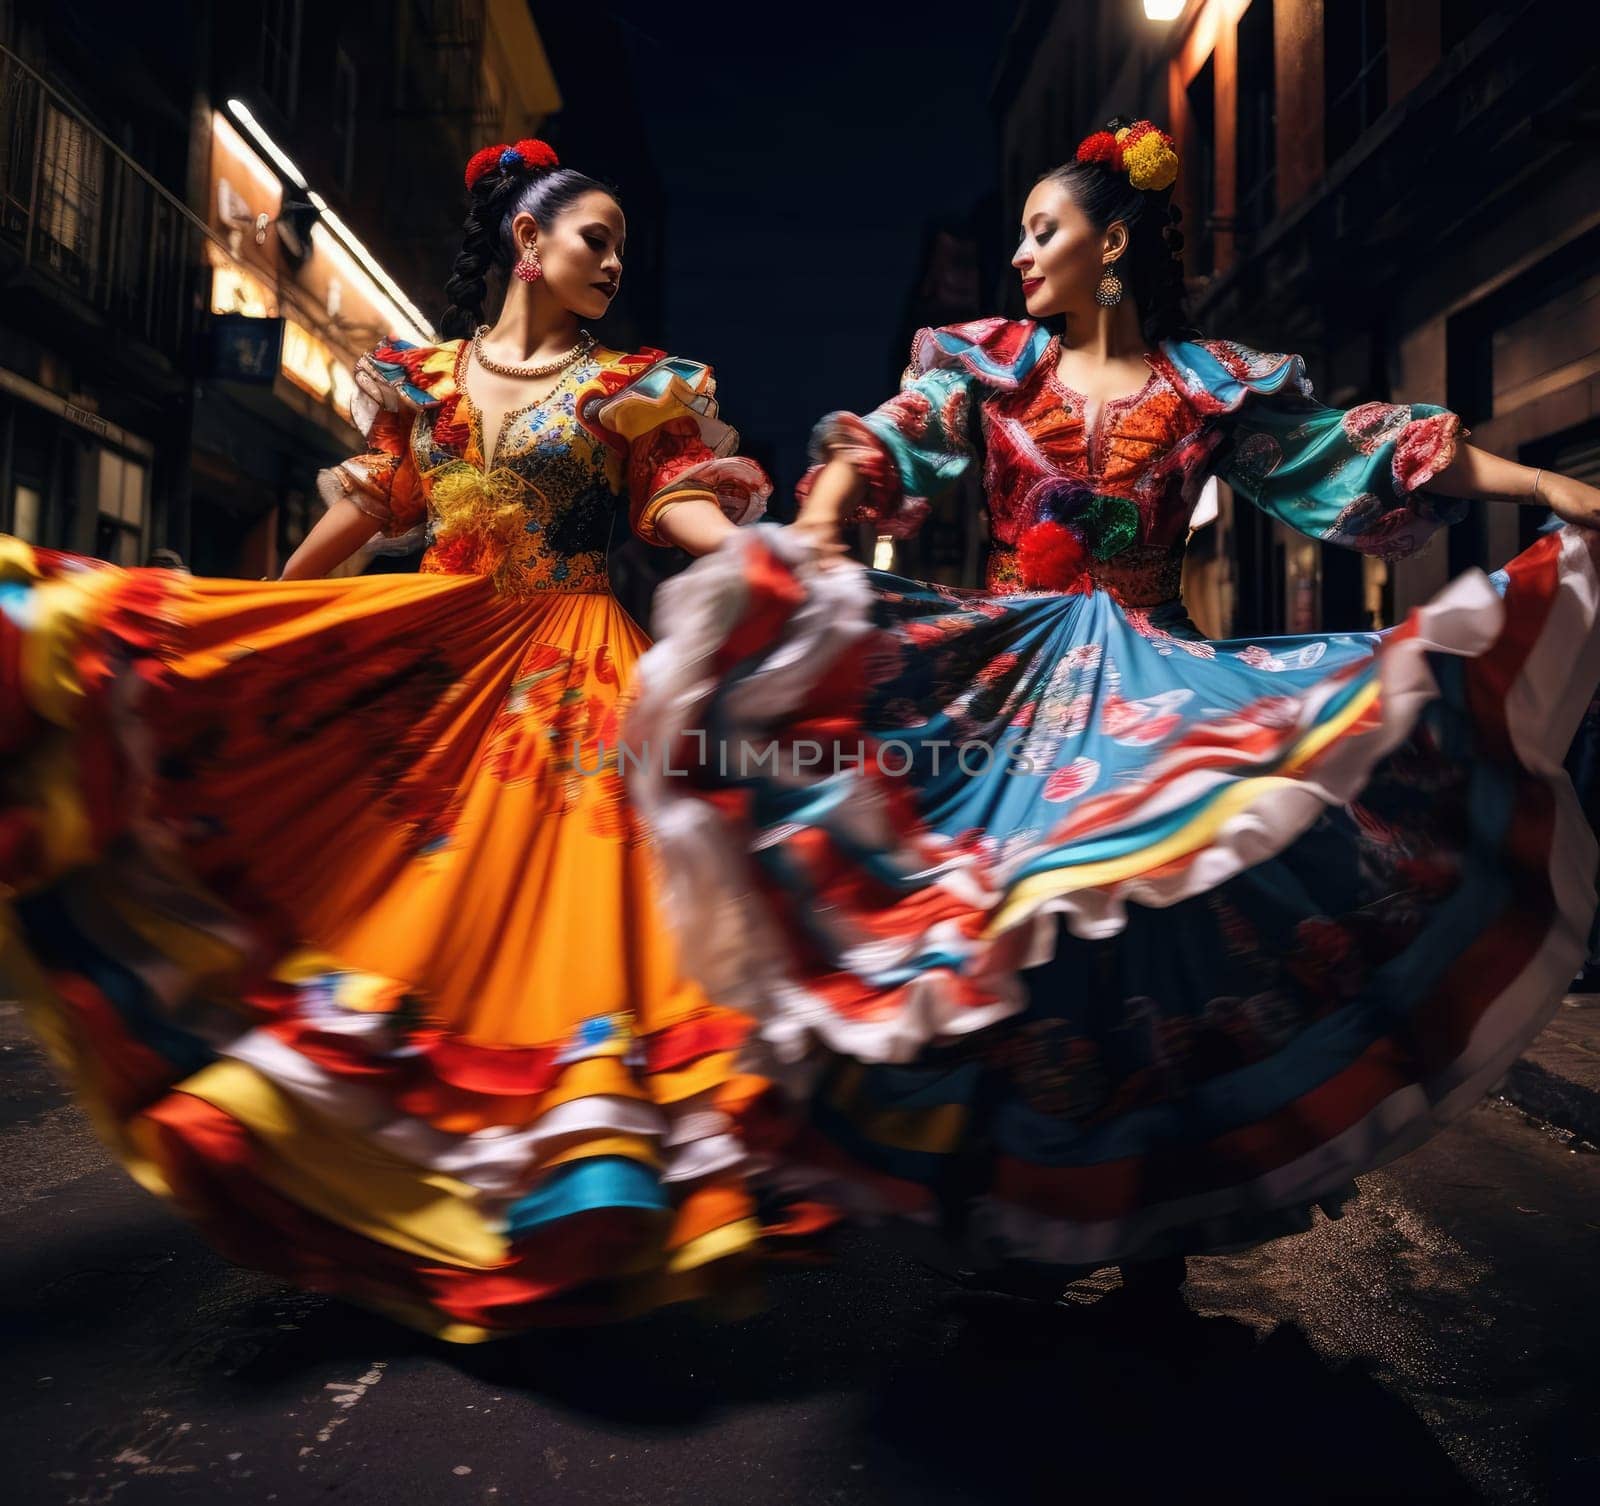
[{"xmin": 189, "ymin": 0, "xmax": 562, "ymax": 575}]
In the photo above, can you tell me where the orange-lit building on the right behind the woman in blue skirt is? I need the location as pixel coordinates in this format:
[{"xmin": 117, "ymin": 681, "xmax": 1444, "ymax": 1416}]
[{"xmin": 994, "ymin": 0, "xmax": 1600, "ymax": 634}]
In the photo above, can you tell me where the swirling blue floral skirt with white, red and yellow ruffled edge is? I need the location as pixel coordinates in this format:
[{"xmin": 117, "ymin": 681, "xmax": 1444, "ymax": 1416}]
[{"xmin": 627, "ymin": 527, "xmax": 1600, "ymax": 1266}]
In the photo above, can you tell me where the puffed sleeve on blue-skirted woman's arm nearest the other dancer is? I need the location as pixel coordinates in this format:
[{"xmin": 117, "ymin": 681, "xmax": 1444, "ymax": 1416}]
[{"xmin": 797, "ymin": 318, "xmax": 1050, "ymax": 538}]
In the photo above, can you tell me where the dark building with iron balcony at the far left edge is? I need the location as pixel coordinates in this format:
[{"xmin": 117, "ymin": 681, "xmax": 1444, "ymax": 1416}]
[{"xmin": 0, "ymin": 3, "xmax": 202, "ymax": 563}]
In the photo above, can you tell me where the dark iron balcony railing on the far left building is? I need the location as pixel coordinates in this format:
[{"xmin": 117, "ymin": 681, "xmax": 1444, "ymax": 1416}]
[{"xmin": 0, "ymin": 48, "xmax": 206, "ymax": 362}]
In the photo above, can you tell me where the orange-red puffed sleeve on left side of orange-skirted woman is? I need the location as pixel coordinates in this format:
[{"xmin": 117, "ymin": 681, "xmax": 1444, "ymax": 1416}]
[{"xmin": 317, "ymin": 341, "xmax": 432, "ymax": 538}]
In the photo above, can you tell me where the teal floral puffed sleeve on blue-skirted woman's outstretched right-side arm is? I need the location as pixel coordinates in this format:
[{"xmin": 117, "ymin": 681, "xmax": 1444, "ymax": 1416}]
[{"xmin": 1165, "ymin": 341, "xmax": 1467, "ymax": 559}]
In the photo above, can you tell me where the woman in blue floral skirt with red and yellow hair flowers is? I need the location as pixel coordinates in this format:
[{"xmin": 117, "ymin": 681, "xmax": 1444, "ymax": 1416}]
[{"xmin": 629, "ymin": 120, "xmax": 1600, "ymax": 1290}]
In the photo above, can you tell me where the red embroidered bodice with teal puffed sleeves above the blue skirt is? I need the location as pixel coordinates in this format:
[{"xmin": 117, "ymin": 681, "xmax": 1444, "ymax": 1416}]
[{"xmin": 802, "ymin": 318, "xmax": 1459, "ymax": 605}]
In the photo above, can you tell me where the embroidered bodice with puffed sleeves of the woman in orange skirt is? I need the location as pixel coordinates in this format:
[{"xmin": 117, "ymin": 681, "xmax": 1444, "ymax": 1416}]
[{"xmin": 322, "ymin": 341, "xmax": 771, "ymax": 595}]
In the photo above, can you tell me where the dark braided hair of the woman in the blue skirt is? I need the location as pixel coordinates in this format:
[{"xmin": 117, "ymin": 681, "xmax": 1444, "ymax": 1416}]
[{"xmin": 1040, "ymin": 115, "xmax": 1198, "ymax": 346}]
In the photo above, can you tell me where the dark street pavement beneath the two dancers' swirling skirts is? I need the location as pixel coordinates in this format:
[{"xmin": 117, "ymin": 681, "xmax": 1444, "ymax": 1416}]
[{"xmin": 0, "ymin": 1007, "xmax": 1600, "ymax": 1506}]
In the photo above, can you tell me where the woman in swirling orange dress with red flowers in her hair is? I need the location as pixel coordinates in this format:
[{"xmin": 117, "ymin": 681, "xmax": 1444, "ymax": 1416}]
[{"xmin": 0, "ymin": 141, "xmax": 821, "ymax": 1340}]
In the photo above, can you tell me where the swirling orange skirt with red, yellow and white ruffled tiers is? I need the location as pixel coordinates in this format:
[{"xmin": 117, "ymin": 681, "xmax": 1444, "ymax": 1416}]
[{"xmin": 0, "ymin": 539, "xmax": 830, "ymax": 1341}]
